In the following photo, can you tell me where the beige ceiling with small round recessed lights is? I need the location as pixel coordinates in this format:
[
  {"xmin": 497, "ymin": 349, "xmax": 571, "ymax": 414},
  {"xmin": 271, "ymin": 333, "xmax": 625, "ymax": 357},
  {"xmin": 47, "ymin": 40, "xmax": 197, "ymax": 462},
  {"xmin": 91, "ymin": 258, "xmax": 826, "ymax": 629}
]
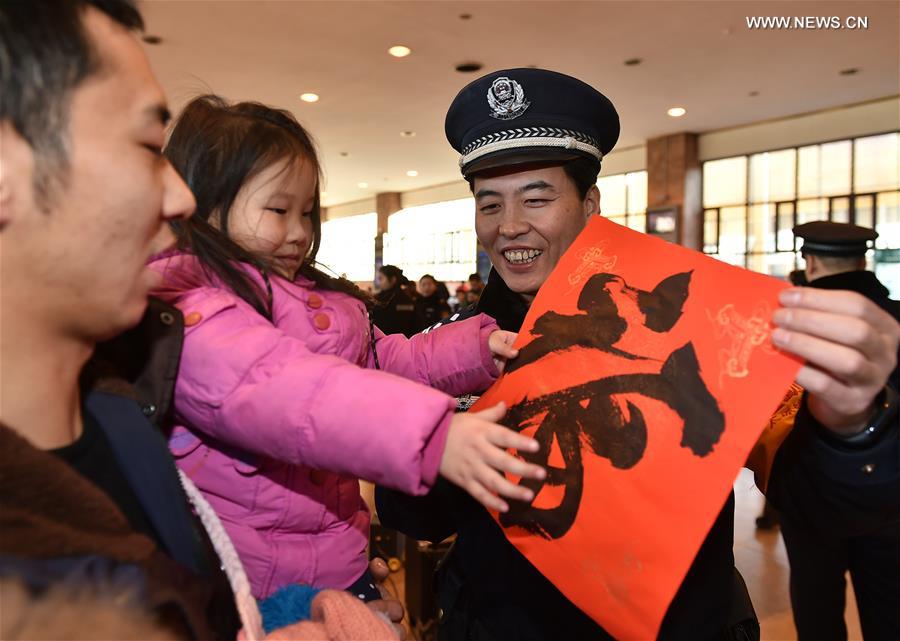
[{"xmin": 142, "ymin": 0, "xmax": 900, "ymax": 205}]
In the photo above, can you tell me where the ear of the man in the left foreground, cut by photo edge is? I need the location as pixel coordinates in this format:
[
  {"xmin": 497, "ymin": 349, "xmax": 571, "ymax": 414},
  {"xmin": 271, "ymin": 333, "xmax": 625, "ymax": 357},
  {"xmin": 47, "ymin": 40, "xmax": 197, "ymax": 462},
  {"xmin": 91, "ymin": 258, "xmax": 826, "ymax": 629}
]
[{"xmin": 0, "ymin": 120, "xmax": 35, "ymax": 231}]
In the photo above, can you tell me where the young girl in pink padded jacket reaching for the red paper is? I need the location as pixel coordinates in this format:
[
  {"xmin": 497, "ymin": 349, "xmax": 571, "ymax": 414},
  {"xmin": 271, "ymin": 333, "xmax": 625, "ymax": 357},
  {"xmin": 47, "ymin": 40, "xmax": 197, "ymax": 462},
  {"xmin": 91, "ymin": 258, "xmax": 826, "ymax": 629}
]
[{"xmin": 152, "ymin": 96, "xmax": 544, "ymax": 598}]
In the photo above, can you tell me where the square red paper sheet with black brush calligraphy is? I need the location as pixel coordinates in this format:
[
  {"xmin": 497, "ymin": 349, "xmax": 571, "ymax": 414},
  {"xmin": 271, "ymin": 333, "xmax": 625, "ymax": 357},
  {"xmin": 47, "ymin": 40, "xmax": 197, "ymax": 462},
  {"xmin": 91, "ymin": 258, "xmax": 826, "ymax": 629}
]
[{"xmin": 473, "ymin": 217, "xmax": 800, "ymax": 641}]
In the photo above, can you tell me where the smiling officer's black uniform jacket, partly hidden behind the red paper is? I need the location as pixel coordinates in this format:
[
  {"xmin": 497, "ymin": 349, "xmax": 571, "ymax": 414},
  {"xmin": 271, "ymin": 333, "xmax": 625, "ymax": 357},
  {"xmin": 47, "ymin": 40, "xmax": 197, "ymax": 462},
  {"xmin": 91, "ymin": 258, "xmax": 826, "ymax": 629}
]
[{"xmin": 376, "ymin": 272, "xmax": 900, "ymax": 641}]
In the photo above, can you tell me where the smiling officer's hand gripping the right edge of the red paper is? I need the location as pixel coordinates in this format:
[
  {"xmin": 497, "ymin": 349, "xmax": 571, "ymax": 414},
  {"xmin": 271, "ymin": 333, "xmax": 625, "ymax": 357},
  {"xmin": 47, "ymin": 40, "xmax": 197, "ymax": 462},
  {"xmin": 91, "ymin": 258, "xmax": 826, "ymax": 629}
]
[{"xmin": 772, "ymin": 287, "xmax": 900, "ymax": 435}]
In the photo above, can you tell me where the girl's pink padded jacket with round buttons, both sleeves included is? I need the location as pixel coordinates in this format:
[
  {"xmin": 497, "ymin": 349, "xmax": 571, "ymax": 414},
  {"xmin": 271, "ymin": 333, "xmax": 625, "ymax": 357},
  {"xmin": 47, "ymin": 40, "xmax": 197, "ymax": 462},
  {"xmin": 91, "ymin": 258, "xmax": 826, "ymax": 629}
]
[{"xmin": 151, "ymin": 254, "xmax": 497, "ymax": 598}]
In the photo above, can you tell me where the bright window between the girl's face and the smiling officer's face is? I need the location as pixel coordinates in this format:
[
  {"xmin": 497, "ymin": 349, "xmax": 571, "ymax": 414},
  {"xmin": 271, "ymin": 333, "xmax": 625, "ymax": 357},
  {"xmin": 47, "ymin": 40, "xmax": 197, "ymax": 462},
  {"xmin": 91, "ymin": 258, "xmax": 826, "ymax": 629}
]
[{"xmin": 384, "ymin": 198, "xmax": 477, "ymax": 281}]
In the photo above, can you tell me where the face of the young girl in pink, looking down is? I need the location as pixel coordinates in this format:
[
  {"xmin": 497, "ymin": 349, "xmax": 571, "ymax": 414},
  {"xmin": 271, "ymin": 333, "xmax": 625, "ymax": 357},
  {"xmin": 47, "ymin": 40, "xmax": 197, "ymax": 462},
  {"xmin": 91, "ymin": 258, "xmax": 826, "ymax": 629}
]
[{"xmin": 228, "ymin": 158, "xmax": 317, "ymax": 280}]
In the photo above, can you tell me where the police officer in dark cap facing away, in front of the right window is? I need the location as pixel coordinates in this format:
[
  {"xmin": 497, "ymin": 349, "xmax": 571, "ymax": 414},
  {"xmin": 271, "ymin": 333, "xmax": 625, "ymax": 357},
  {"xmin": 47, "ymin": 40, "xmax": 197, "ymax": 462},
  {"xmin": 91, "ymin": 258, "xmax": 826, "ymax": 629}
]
[{"xmin": 781, "ymin": 221, "xmax": 900, "ymax": 641}]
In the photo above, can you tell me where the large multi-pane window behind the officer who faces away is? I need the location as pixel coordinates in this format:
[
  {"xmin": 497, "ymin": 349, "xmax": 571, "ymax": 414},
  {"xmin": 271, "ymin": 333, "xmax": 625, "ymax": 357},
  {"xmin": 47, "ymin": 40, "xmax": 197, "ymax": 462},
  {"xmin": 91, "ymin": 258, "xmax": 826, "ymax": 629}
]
[{"xmin": 703, "ymin": 132, "xmax": 900, "ymax": 295}]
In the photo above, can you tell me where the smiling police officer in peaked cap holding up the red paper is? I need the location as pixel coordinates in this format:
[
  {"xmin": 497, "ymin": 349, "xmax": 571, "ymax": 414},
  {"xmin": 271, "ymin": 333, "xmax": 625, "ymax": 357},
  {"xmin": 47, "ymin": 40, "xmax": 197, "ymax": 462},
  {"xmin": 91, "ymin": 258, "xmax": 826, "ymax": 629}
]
[{"xmin": 376, "ymin": 69, "xmax": 900, "ymax": 641}]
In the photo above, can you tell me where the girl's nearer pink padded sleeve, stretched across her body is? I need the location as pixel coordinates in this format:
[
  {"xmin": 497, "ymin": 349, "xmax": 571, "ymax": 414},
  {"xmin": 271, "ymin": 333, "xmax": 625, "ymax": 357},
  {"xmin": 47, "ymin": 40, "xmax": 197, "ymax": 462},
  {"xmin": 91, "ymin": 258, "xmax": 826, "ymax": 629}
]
[{"xmin": 167, "ymin": 289, "xmax": 455, "ymax": 494}]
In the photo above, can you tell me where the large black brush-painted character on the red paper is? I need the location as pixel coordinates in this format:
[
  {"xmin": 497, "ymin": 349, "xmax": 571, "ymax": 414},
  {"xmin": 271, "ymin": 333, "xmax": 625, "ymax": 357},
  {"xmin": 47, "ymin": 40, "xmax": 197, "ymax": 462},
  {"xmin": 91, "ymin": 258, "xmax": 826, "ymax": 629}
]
[{"xmin": 500, "ymin": 272, "xmax": 725, "ymax": 539}]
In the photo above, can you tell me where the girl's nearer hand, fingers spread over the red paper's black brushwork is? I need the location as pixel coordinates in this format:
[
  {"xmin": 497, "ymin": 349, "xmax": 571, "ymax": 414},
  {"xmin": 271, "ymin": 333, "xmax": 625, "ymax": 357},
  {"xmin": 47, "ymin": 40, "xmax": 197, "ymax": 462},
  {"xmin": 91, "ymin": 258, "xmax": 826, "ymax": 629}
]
[{"xmin": 440, "ymin": 403, "xmax": 547, "ymax": 512}]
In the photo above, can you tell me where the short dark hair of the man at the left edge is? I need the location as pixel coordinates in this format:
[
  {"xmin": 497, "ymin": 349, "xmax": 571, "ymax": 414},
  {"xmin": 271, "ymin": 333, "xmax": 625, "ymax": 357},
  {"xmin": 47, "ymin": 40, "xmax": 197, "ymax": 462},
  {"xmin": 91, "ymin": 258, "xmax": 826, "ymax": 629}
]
[{"xmin": 0, "ymin": 0, "xmax": 144, "ymax": 205}]
